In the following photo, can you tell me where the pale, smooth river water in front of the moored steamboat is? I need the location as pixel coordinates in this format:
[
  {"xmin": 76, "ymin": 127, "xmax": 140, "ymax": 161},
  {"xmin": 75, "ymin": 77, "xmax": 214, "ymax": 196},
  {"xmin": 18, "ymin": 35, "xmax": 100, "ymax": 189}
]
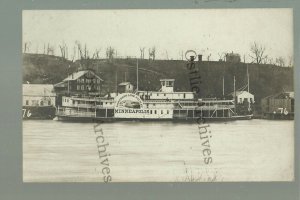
[{"xmin": 23, "ymin": 119, "xmax": 294, "ymax": 182}]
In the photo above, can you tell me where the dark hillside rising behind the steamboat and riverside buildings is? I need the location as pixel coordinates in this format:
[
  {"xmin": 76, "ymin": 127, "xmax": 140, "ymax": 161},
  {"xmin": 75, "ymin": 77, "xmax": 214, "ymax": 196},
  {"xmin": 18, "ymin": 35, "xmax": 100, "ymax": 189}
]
[{"xmin": 23, "ymin": 54, "xmax": 293, "ymax": 102}]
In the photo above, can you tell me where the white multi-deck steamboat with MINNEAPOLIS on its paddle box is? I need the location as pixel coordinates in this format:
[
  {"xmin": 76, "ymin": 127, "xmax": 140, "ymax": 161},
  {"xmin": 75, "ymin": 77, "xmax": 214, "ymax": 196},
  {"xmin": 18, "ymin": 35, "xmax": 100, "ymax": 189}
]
[{"xmin": 56, "ymin": 79, "xmax": 252, "ymax": 121}]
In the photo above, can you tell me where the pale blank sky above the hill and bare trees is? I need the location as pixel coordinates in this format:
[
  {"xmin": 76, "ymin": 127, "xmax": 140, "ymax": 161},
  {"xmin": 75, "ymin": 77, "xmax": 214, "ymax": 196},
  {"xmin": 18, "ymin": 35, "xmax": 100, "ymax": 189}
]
[{"xmin": 22, "ymin": 9, "xmax": 293, "ymax": 62}]
